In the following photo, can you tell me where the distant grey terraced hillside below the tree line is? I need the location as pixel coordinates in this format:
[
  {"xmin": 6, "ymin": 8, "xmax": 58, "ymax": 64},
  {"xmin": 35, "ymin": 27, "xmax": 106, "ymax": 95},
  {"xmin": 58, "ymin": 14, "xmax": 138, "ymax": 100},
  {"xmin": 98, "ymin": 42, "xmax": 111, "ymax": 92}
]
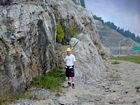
[{"xmin": 95, "ymin": 20, "xmax": 140, "ymax": 55}]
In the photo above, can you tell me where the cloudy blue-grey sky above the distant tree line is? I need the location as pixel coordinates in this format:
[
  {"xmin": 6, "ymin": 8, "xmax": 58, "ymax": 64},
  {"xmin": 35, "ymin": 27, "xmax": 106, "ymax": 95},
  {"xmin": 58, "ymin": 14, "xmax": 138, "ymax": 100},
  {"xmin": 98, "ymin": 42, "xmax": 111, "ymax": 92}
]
[{"xmin": 85, "ymin": 0, "xmax": 140, "ymax": 36}]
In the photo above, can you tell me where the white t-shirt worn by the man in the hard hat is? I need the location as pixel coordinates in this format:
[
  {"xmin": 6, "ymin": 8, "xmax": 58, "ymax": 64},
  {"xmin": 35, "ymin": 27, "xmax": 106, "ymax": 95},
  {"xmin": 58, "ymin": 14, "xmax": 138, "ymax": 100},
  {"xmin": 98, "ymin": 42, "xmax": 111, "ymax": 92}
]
[{"xmin": 64, "ymin": 54, "xmax": 76, "ymax": 66}]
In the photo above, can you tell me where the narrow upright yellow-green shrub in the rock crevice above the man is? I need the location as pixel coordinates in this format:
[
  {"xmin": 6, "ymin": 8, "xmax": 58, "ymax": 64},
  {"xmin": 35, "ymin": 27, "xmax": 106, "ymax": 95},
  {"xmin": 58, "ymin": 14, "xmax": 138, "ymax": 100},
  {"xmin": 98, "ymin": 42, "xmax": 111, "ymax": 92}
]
[{"xmin": 56, "ymin": 23, "xmax": 64, "ymax": 43}]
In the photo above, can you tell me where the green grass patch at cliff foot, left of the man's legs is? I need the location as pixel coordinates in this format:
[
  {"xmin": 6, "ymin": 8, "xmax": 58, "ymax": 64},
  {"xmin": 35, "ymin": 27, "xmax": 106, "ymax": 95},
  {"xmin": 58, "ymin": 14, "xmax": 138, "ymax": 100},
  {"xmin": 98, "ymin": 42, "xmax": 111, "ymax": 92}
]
[{"xmin": 33, "ymin": 66, "xmax": 65, "ymax": 92}]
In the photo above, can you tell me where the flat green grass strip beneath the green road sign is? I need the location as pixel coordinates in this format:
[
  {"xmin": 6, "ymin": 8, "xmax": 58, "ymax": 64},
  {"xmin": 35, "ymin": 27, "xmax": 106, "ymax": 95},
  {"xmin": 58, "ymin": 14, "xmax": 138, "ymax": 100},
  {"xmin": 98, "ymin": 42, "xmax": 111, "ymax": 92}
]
[{"xmin": 111, "ymin": 56, "xmax": 140, "ymax": 64}]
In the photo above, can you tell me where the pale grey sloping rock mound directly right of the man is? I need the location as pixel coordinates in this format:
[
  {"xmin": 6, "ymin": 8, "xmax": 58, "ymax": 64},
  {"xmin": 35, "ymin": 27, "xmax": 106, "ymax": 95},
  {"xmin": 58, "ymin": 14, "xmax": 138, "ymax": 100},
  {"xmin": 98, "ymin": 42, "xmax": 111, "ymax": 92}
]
[{"xmin": 70, "ymin": 33, "xmax": 105, "ymax": 84}]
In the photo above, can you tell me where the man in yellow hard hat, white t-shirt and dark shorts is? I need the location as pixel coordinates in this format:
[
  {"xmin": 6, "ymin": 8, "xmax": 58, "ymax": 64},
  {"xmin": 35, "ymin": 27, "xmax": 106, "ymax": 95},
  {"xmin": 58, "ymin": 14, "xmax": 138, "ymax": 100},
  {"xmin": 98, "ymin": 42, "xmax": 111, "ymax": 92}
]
[{"xmin": 64, "ymin": 48, "xmax": 76, "ymax": 89}]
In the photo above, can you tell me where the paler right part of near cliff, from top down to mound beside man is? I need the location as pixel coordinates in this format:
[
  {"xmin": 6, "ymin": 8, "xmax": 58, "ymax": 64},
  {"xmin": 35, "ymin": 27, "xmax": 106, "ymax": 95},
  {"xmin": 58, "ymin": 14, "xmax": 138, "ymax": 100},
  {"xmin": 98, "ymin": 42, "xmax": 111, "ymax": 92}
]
[{"xmin": 48, "ymin": 1, "xmax": 108, "ymax": 83}]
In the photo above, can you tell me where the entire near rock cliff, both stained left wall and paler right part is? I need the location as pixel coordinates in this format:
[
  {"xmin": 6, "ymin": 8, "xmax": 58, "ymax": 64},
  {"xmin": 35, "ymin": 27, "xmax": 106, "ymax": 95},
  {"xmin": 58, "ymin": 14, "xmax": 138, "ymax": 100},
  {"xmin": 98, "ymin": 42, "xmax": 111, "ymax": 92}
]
[{"xmin": 0, "ymin": 0, "xmax": 105, "ymax": 96}]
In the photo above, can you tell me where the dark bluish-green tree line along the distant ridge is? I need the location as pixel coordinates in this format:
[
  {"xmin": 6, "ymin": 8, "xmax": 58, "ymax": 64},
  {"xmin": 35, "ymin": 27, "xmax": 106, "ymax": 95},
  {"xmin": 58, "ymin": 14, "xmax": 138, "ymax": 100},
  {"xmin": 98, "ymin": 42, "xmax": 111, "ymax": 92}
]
[{"xmin": 93, "ymin": 15, "xmax": 140, "ymax": 43}]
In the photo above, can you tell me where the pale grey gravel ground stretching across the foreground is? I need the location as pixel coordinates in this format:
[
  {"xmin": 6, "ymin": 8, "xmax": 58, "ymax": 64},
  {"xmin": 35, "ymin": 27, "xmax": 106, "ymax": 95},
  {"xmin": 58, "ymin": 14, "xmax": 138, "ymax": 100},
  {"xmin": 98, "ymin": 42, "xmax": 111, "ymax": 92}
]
[{"xmin": 9, "ymin": 60, "xmax": 140, "ymax": 105}]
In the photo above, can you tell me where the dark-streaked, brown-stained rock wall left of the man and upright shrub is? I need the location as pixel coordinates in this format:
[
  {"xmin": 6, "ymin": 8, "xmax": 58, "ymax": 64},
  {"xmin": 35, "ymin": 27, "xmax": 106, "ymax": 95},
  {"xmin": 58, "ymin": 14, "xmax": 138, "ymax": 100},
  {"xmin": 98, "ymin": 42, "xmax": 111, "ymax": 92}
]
[{"xmin": 0, "ymin": 3, "xmax": 58, "ymax": 95}]
